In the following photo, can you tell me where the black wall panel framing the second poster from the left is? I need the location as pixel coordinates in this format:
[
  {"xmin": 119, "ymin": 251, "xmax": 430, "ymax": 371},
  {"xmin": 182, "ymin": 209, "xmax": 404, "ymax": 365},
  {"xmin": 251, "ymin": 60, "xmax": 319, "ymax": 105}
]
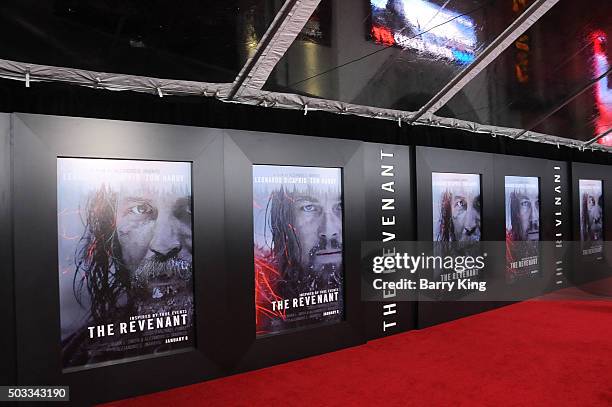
[{"xmin": 224, "ymin": 131, "xmax": 365, "ymax": 372}]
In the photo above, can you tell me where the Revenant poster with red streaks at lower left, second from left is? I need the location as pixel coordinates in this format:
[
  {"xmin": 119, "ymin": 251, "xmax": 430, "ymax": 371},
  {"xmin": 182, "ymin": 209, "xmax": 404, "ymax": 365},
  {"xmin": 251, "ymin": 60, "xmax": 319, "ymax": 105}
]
[{"xmin": 253, "ymin": 165, "xmax": 344, "ymax": 336}]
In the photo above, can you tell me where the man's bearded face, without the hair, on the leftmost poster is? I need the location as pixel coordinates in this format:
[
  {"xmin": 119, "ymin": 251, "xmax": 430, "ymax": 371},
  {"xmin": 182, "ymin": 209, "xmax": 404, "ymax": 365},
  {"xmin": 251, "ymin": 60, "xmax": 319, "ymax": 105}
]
[{"xmin": 116, "ymin": 187, "xmax": 192, "ymax": 303}]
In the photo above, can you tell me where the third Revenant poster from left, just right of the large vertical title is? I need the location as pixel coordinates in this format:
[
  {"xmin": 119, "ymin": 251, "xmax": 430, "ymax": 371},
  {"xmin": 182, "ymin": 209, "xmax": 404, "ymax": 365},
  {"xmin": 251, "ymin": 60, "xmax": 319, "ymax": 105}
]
[{"xmin": 431, "ymin": 172, "xmax": 481, "ymax": 281}]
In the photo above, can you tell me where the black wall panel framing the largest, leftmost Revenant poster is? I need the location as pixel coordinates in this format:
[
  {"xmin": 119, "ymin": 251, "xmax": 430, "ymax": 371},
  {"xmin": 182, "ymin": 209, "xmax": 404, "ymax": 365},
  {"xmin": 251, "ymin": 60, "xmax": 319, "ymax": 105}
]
[{"xmin": 13, "ymin": 114, "xmax": 224, "ymax": 405}]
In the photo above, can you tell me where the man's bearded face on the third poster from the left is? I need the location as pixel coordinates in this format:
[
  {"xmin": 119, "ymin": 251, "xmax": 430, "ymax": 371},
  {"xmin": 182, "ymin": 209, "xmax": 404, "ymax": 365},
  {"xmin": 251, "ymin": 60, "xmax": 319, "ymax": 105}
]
[{"xmin": 450, "ymin": 187, "xmax": 480, "ymax": 242}]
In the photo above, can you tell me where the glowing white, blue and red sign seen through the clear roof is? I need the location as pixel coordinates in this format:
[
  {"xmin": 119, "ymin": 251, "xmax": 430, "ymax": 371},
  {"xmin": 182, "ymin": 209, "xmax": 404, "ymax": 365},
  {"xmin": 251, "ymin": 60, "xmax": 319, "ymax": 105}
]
[{"xmin": 370, "ymin": 0, "xmax": 477, "ymax": 64}]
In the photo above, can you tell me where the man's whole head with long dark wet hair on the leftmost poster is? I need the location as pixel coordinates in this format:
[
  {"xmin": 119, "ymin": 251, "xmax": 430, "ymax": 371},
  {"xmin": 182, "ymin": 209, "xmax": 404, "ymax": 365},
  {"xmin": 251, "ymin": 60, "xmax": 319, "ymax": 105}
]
[{"xmin": 74, "ymin": 182, "xmax": 193, "ymax": 321}]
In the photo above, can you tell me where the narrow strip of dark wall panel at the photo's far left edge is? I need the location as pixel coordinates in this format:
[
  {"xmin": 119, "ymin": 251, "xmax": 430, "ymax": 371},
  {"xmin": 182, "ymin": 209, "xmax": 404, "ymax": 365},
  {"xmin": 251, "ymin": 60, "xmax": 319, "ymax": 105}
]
[{"xmin": 0, "ymin": 114, "xmax": 15, "ymax": 385}]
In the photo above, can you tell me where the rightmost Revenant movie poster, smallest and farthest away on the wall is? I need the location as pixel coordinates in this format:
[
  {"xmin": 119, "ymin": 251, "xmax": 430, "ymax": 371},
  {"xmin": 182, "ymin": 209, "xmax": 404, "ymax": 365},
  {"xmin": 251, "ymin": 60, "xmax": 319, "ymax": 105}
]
[{"xmin": 578, "ymin": 179, "xmax": 604, "ymax": 256}]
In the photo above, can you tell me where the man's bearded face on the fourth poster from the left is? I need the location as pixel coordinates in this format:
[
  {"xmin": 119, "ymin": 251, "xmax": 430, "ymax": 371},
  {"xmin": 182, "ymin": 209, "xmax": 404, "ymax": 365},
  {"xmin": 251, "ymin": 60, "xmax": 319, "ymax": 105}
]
[{"xmin": 510, "ymin": 190, "xmax": 540, "ymax": 241}]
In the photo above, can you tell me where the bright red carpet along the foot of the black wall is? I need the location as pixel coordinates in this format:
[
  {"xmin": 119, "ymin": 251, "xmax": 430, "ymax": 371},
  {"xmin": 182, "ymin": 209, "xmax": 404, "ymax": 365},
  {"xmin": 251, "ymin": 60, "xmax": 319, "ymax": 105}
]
[{"xmin": 101, "ymin": 301, "xmax": 612, "ymax": 407}]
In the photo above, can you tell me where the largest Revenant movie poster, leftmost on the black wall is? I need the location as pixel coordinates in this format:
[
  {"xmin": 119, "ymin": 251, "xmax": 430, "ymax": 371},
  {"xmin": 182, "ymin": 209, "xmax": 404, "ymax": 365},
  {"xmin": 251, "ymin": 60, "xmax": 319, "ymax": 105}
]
[{"xmin": 57, "ymin": 158, "xmax": 194, "ymax": 371}]
